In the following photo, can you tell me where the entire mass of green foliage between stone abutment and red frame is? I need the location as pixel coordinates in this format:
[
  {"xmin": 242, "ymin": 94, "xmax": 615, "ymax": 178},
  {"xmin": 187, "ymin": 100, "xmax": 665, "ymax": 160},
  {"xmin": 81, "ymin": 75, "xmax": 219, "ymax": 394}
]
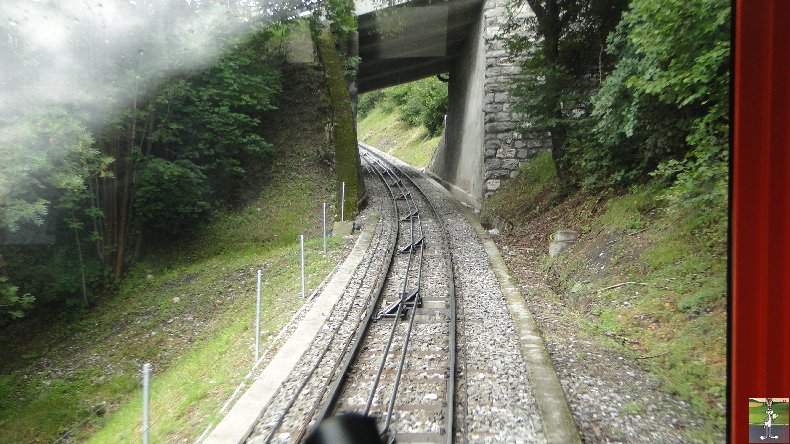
[{"xmin": 507, "ymin": 0, "xmax": 730, "ymax": 220}]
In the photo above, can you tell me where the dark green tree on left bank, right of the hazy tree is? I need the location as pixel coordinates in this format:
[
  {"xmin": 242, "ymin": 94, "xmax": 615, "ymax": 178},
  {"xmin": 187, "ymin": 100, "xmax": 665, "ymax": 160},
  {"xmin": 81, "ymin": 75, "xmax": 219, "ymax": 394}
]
[{"xmin": 87, "ymin": 24, "xmax": 280, "ymax": 281}]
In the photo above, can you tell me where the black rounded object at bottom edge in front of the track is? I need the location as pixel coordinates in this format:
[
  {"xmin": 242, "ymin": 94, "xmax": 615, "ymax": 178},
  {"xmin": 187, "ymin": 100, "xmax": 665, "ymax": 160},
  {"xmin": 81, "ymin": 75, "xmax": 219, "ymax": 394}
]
[{"xmin": 306, "ymin": 413, "xmax": 383, "ymax": 444}]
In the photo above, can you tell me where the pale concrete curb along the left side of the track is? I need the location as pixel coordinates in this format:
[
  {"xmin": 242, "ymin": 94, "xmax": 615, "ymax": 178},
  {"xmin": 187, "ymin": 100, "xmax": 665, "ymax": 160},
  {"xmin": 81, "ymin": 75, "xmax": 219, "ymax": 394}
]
[{"xmin": 203, "ymin": 213, "xmax": 381, "ymax": 444}]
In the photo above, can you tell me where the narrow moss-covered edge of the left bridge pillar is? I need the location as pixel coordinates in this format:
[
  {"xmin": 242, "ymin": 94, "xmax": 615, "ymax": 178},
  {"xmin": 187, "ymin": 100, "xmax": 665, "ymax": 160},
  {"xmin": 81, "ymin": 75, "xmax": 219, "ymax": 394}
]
[{"xmin": 316, "ymin": 30, "xmax": 365, "ymax": 219}]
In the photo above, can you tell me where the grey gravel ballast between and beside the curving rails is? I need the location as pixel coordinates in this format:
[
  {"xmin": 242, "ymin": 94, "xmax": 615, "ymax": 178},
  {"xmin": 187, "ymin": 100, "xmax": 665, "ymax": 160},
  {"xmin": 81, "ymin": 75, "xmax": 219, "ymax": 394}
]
[{"xmin": 237, "ymin": 147, "xmax": 576, "ymax": 443}]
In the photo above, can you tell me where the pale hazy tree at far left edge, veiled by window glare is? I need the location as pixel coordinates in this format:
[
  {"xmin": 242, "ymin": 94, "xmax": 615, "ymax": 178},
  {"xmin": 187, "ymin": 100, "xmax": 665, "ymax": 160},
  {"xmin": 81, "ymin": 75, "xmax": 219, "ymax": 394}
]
[{"xmin": 0, "ymin": 110, "xmax": 106, "ymax": 317}]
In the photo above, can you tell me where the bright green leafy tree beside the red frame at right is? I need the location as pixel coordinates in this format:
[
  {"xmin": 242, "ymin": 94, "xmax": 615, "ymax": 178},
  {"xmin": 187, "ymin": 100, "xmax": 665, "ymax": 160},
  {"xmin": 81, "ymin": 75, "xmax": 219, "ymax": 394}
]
[{"xmin": 593, "ymin": 0, "xmax": 730, "ymax": 214}]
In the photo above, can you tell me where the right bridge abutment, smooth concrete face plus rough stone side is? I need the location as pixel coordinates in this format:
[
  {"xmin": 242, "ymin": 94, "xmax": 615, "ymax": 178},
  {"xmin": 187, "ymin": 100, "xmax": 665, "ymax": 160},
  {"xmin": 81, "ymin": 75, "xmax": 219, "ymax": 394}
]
[{"xmin": 428, "ymin": 0, "xmax": 550, "ymax": 208}]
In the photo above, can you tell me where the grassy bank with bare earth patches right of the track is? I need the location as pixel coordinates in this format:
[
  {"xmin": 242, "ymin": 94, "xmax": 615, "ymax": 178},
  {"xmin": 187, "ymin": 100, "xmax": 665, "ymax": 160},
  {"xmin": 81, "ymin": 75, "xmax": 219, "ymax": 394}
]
[{"xmin": 481, "ymin": 154, "xmax": 727, "ymax": 440}]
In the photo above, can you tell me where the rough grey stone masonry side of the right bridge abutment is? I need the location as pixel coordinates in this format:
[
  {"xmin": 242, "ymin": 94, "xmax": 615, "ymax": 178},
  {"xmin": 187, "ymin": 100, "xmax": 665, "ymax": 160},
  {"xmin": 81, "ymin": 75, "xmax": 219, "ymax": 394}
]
[{"xmin": 483, "ymin": 0, "xmax": 550, "ymax": 197}]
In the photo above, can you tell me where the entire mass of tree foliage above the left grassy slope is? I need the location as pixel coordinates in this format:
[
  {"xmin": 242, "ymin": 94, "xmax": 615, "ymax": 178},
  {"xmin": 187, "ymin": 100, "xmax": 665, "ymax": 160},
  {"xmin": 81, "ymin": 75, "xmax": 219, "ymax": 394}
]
[{"xmin": 0, "ymin": 24, "xmax": 280, "ymax": 323}]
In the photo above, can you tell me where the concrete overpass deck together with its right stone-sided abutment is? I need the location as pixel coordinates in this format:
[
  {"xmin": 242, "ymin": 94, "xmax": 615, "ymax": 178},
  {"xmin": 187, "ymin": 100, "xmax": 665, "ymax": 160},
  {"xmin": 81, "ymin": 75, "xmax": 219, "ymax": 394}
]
[{"xmin": 356, "ymin": 0, "xmax": 548, "ymax": 208}]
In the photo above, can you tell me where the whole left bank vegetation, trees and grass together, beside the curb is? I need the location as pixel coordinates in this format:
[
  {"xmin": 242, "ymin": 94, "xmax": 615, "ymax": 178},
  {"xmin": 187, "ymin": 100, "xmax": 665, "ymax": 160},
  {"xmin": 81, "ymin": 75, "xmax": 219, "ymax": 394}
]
[{"xmin": 0, "ymin": 0, "xmax": 366, "ymax": 442}]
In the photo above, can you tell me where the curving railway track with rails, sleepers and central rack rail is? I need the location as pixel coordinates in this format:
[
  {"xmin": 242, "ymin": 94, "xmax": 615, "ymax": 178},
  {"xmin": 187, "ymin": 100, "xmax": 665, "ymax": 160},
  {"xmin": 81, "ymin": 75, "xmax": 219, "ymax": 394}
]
[{"xmin": 248, "ymin": 149, "xmax": 456, "ymax": 443}]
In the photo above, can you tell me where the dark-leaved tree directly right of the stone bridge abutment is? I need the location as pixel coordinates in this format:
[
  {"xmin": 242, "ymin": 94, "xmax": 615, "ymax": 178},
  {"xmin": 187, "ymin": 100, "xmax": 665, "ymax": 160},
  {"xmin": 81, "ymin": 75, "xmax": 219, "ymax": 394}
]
[{"xmin": 505, "ymin": 0, "xmax": 626, "ymax": 184}]
